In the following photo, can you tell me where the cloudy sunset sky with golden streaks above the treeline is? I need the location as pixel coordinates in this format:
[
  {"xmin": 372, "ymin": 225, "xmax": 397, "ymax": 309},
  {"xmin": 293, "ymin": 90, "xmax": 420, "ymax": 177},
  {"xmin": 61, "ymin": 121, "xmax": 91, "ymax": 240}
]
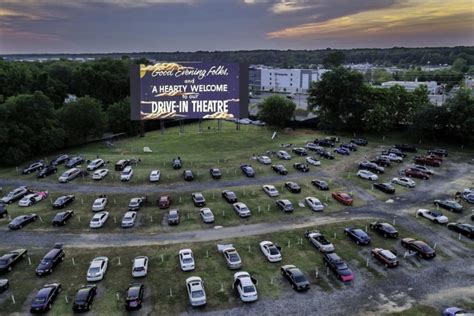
[{"xmin": 0, "ymin": 0, "xmax": 474, "ymax": 54}]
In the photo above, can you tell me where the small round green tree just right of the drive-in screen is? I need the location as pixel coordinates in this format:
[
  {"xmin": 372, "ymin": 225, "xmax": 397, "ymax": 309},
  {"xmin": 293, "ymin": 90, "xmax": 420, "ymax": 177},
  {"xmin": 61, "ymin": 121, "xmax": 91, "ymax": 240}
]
[{"xmin": 258, "ymin": 95, "xmax": 296, "ymax": 127}]
